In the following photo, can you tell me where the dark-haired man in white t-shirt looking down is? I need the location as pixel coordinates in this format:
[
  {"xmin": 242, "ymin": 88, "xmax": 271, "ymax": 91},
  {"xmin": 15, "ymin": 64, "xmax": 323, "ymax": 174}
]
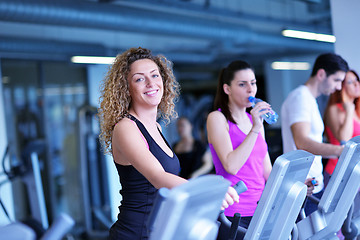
[{"xmin": 281, "ymin": 53, "xmax": 349, "ymax": 215}]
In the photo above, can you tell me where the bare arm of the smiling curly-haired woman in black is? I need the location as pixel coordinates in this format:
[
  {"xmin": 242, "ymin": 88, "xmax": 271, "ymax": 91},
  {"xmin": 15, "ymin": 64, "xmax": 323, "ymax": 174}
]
[{"xmin": 113, "ymin": 118, "xmax": 186, "ymax": 188}]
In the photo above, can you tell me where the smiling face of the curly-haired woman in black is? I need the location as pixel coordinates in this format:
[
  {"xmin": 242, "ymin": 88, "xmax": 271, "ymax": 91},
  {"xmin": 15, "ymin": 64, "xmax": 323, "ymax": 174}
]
[{"xmin": 127, "ymin": 59, "xmax": 163, "ymax": 109}]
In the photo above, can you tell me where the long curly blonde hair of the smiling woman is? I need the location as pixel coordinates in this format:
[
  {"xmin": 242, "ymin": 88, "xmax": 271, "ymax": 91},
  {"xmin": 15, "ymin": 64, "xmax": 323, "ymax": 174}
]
[{"xmin": 98, "ymin": 47, "xmax": 180, "ymax": 154}]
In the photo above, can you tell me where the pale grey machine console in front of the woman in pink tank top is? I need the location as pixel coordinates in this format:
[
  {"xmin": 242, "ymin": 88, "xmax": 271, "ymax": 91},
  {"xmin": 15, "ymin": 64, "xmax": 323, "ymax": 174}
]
[{"xmin": 221, "ymin": 150, "xmax": 315, "ymax": 240}]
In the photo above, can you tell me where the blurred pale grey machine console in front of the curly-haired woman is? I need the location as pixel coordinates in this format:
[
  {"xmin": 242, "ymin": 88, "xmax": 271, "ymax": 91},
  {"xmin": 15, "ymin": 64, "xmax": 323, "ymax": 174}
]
[{"xmin": 149, "ymin": 175, "xmax": 230, "ymax": 240}]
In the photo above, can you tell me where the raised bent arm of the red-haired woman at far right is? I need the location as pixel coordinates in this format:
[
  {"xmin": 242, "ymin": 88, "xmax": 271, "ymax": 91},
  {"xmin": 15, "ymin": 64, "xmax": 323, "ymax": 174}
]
[{"xmin": 325, "ymin": 102, "xmax": 355, "ymax": 142}]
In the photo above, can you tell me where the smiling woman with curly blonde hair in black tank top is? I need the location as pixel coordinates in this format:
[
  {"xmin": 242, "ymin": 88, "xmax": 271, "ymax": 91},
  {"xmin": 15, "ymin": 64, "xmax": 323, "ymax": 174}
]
[{"xmin": 99, "ymin": 48, "xmax": 238, "ymax": 239}]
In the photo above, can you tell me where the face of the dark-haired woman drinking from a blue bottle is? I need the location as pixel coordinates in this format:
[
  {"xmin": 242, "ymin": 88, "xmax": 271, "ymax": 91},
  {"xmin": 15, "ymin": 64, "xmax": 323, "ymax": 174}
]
[{"xmin": 224, "ymin": 69, "xmax": 257, "ymax": 107}]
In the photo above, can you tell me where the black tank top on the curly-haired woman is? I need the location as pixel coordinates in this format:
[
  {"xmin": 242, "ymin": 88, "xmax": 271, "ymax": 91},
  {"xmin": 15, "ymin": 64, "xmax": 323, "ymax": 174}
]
[{"xmin": 110, "ymin": 115, "xmax": 180, "ymax": 240}]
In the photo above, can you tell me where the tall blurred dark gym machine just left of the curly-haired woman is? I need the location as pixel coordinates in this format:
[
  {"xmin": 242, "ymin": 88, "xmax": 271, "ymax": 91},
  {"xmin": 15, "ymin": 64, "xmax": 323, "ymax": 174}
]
[{"xmin": 78, "ymin": 105, "xmax": 112, "ymax": 238}]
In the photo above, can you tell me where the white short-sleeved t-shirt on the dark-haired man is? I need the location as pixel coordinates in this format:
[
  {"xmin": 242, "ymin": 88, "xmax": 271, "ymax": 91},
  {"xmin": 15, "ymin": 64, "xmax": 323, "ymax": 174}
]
[{"xmin": 281, "ymin": 85, "xmax": 324, "ymax": 193}]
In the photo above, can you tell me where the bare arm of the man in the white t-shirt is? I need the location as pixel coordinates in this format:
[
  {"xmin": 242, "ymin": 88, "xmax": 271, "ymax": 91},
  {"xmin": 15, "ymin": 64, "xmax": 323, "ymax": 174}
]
[{"xmin": 291, "ymin": 122, "xmax": 344, "ymax": 156}]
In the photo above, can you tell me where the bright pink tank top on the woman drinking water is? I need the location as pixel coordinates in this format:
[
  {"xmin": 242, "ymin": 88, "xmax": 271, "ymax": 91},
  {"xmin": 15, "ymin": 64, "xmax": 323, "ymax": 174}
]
[{"xmin": 209, "ymin": 113, "xmax": 268, "ymax": 217}]
